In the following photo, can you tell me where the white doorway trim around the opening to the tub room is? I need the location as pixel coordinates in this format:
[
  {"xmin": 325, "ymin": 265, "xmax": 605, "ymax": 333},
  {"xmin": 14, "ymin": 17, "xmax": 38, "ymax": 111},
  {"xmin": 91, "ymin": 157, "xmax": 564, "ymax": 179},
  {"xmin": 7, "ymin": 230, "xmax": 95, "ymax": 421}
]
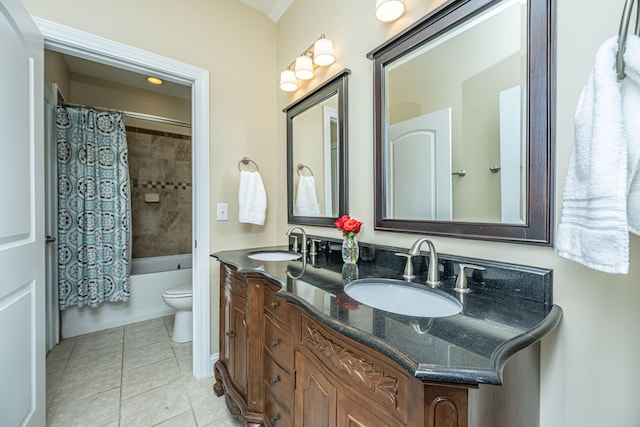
[{"xmin": 32, "ymin": 16, "xmax": 215, "ymax": 379}]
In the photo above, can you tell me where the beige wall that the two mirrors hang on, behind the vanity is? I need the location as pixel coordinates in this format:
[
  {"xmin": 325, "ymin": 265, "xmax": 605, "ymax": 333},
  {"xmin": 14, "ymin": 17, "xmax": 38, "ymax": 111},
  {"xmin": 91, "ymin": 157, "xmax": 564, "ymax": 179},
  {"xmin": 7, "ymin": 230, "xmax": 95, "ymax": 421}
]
[{"xmin": 276, "ymin": 0, "xmax": 640, "ymax": 427}]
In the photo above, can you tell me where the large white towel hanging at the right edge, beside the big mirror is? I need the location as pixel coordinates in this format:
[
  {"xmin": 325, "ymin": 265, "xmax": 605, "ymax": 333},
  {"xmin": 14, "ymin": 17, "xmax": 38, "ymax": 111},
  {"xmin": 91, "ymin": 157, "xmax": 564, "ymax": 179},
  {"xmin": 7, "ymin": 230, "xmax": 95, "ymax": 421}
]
[{"xmin": 556, "ymin": 35, "xmax": 640, "ymax": 274}]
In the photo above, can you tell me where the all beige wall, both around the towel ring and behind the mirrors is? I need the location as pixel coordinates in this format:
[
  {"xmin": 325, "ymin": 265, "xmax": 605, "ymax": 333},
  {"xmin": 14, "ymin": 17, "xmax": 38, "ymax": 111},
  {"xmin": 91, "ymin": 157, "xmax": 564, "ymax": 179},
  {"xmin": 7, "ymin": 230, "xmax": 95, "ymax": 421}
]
[{"xmin": 23, "ymin": 0, "xmax": 640, "ymax": 427}]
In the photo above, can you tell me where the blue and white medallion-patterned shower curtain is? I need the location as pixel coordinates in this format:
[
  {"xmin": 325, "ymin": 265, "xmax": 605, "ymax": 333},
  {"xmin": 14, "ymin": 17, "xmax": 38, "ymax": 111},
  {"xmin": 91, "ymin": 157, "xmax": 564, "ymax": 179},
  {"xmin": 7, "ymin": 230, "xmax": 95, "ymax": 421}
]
[{"xmin": 56, "ymin": 106, "xmax": 131, "ymax": 310}]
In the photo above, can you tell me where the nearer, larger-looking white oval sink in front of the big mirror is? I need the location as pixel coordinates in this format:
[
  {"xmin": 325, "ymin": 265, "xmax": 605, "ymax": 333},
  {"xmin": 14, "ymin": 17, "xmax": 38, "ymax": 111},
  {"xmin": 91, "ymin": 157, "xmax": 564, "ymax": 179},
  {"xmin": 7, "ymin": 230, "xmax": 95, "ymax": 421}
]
[{"xmin": 344, "ymin": 279, "xmax": 462, "ymax": 317}]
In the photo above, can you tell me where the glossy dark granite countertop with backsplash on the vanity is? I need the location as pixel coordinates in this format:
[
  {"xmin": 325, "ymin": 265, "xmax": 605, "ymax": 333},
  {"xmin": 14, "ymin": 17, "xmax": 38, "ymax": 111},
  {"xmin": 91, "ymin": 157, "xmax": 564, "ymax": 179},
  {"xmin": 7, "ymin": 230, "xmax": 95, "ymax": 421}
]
[{"xmin": 211, "ymin": 238, "xmax": 562, "ymax": 384}]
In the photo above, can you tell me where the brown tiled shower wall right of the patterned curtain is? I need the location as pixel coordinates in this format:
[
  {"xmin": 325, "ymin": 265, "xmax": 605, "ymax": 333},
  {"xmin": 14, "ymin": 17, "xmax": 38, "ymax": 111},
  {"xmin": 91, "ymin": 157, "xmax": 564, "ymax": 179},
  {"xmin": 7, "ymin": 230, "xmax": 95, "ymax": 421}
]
[{"xmin": 127, "ymin": 126, "xmax": 192, "ymax": 258}]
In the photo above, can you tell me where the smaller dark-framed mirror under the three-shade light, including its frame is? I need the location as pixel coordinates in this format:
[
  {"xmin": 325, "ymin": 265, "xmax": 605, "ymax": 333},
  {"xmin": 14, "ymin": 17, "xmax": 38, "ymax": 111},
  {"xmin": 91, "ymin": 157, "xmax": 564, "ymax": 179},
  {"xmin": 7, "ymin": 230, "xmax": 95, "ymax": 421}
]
[{"xmin": 283, "ymin": 69, "xmax": 350, "ymax": 226}]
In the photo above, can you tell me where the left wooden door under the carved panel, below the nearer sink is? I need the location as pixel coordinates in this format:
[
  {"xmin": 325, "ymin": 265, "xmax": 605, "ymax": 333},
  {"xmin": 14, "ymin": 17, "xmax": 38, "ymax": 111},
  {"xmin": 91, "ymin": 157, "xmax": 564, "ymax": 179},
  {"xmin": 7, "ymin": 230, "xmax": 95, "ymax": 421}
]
[{"xmin": 294, "ymin": 351, "xmax": 337, "ymax": 427}]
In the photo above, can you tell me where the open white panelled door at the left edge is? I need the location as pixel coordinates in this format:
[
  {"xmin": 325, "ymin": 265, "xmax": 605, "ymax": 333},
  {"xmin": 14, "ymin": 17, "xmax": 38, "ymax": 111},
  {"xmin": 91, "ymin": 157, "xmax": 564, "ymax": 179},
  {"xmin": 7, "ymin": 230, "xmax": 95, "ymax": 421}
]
[{"xmin": 0, "ymin": 0, "xmax": 46, "ymax": 427}]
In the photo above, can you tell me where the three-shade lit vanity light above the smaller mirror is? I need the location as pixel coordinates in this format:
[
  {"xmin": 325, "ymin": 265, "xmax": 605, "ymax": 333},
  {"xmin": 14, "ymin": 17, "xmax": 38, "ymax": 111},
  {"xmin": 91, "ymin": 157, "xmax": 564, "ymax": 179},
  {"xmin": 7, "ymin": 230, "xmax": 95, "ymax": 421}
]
[{"xmin": 280, "ymin": 34, "xmax": 336, "ymax": 92}]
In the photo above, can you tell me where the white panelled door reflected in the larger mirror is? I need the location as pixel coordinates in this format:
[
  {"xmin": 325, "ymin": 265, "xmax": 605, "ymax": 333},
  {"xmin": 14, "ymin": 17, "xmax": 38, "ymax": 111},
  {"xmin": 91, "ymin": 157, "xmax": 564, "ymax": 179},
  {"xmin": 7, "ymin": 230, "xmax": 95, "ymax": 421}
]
[{"xmin": 386, "ymin": 108, "xmax": 452, "ymax": 220}]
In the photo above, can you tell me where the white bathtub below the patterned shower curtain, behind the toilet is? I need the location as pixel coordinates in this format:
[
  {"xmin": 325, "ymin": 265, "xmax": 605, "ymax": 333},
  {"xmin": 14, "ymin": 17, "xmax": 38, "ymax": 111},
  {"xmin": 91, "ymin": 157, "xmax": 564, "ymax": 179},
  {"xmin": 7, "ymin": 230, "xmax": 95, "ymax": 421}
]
[{"xmin": 61, "ymin": 254, "xmax": 192, "ymax": 338}]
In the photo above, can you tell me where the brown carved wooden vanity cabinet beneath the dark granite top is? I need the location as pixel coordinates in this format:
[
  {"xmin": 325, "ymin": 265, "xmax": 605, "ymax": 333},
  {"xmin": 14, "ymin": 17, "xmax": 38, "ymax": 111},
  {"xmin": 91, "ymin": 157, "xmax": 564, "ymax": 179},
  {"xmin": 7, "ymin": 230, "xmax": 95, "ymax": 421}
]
[{"xmin": 214, "ymin": 264, "xmax": 540, "ymax": 427}]
